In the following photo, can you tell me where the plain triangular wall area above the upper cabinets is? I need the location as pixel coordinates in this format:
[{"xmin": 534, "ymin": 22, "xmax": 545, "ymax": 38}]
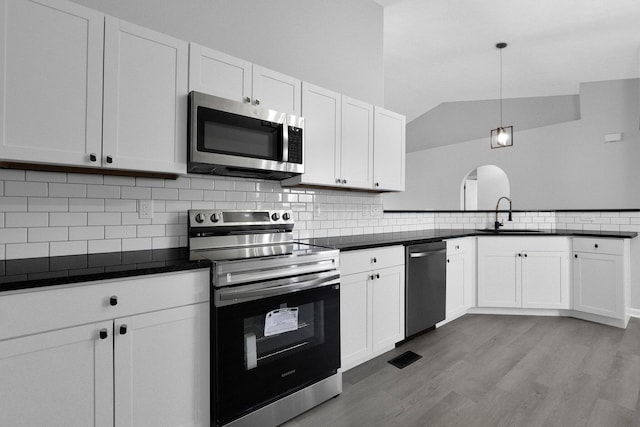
[{"xmin": 68, "ymin": 0, "xmax": 384, "ymax": 106}]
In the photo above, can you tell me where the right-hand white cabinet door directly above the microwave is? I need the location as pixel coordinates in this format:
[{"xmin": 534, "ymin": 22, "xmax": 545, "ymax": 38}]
[{"xmin": 253, "ymin": 65, "xmax": 302, "ymax": 117}]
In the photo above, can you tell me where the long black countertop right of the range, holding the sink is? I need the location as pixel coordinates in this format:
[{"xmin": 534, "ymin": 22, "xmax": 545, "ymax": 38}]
[{"xmin": 305, "ymin": 229, "xmax": 638, "ymax": 251}]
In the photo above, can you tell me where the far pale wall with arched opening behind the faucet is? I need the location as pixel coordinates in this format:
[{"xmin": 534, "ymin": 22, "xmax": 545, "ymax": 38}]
[{"xmin": 383, "ymin": 79, "xmax": 640, "ymax": 210}]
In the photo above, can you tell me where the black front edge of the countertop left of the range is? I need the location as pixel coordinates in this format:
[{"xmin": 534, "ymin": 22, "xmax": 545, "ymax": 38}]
[{"xmin": 0, "ymin": 260, "xmax": 211, "ymax": 296}]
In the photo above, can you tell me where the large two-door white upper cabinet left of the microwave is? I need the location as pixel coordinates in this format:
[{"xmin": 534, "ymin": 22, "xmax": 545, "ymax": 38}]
[{"xmin": 0, "ymin": 0, "xmax": 188, "ymax": 174}]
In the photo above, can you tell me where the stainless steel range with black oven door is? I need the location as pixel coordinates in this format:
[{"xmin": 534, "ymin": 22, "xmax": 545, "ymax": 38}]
[{"xmin": 189, "ymin": 210, "xmax": 342, "ymax": 427}]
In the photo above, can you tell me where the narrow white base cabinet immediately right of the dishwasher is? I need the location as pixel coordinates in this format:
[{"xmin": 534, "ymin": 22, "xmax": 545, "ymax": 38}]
[{"xmin": 444, "ymin": 237, "xmax": 476, "ymax": 322}]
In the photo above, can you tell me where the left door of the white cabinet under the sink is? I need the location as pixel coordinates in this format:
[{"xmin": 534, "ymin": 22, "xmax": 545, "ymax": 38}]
[{"xmin": 478, "ymin": 252, "xmax": 522, "ymax": 307}]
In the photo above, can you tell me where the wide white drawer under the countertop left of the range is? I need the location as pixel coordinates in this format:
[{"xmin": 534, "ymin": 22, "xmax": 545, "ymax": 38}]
[{"xmin": 0, "ymin": 269, "xmax": 209, "ymax": 340}]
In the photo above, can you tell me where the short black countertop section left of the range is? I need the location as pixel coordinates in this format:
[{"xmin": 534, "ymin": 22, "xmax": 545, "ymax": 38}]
[{"xmin": 0, "ymin": 248, "xmax": 211, "ymax": 292}]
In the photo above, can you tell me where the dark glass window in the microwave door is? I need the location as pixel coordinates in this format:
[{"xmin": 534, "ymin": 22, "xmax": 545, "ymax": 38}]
[{"xmin": 198, "ymin": 107, "xmax": 283, "ymax": 161}]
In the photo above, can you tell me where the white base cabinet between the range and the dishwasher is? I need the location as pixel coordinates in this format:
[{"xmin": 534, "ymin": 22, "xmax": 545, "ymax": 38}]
[{"xmin": 340, "ymin": 246, "xmax": 405, "ymax": 370}]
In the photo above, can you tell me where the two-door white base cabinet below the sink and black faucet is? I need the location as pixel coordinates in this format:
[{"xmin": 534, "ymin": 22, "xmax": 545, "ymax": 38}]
[{"xmin": 478, "ymin": 237, "xmax": 571, "ymax": 309}]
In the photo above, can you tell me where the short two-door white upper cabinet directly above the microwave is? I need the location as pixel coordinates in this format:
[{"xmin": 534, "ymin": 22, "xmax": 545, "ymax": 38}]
[{"xmin": 189, "ymin": 43, "xmax": 302, "ymax": 116}]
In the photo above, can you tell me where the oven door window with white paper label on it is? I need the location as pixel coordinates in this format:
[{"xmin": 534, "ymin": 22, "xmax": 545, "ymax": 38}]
[{"xmin": 244, "ymin": 301, "xmax": 324, "ymax": 370}]
